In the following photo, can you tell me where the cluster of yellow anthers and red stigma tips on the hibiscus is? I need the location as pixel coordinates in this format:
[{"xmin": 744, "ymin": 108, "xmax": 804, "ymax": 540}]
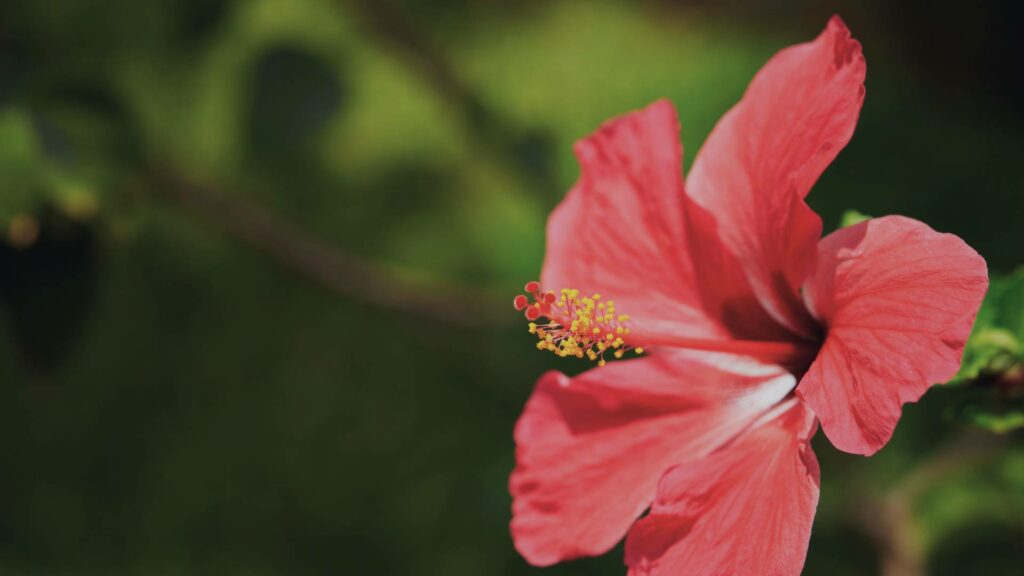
[{"xmin": 513, "ymin": 282, "xmax": 643, "ymax": 366}]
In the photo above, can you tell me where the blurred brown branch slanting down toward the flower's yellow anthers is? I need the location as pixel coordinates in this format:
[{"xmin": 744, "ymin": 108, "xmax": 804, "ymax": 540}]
[{"xmin": 145, "ymin": 166, "xmax": 515, "ymax": 326}]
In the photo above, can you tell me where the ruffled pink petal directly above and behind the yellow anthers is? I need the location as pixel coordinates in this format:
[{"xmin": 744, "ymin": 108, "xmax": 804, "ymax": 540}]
[{"xmin": 541, "ymin": 100, "xmax": 721, "ymax": 337}]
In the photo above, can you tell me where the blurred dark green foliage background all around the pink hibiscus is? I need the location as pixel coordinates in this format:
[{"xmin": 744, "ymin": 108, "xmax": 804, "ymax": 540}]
[{"xmin": 0, "ymin": 0, "xmax": 1024, "ymax": 576}]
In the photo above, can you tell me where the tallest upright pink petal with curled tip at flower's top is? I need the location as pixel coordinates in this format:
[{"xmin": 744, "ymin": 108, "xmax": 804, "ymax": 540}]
[{"xmin": 686, "ymin": 17, "xmax": 865, "ymax": 335}]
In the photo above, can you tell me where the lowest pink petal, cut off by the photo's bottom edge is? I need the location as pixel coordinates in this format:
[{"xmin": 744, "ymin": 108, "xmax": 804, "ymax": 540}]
[{"xmin": 626, "ymin": 399, "xmax": 818, "ymax": 576}]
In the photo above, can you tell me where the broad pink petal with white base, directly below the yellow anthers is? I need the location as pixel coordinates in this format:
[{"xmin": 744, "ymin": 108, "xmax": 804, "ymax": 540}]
[{"xmin": 510, "ymin": 352, "xmax": 795, "ymax": 566}]
